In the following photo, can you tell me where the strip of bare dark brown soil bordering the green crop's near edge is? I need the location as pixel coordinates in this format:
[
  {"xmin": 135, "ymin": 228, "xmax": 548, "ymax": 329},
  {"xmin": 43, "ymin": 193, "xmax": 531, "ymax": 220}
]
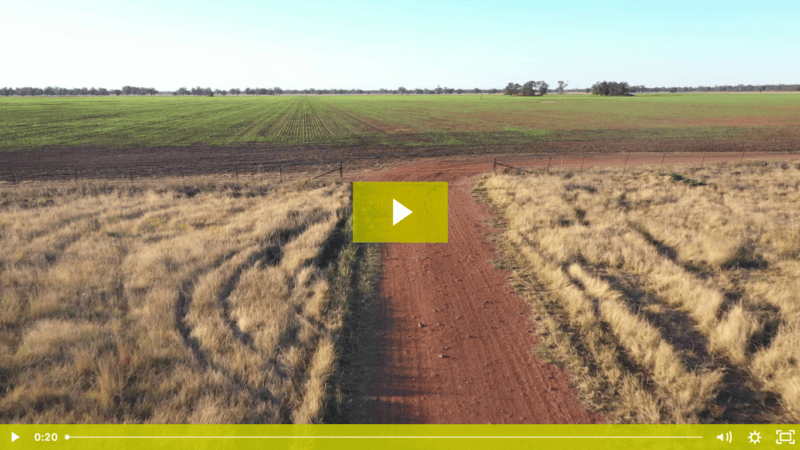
[{"xmin": 0, "ymin": 135, "xmax": 800, "ymax": 184}]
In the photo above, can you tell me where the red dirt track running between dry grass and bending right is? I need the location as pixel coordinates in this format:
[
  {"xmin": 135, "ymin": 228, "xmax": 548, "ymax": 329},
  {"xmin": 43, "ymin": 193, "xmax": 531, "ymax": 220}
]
[{"xmin": 352, "ymin": 153, "xmax": 797, "ymax": 424}]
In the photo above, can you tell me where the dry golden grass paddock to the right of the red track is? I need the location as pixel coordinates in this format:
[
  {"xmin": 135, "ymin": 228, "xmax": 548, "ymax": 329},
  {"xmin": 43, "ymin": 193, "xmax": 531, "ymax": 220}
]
[{"xmin": 478, "ymin": 162, "xmax": 800, "ymax": 423}]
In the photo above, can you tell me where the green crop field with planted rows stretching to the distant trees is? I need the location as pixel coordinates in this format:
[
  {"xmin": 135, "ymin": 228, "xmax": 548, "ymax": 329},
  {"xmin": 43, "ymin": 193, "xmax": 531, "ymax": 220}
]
[{"xmin": 0, "ymin": 94, "xmax": 800, "ymax": 152}]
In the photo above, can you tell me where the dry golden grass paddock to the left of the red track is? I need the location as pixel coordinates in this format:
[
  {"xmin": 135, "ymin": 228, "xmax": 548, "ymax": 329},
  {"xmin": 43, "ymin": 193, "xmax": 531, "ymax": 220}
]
[{"xmin": 0, "ymin": 178, "xmax": 350, "ymax": 423}]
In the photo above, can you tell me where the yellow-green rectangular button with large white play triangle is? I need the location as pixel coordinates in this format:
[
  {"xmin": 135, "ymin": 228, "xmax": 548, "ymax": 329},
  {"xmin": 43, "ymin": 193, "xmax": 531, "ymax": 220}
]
[{"xmin": 353, "ymin": 182, "xmax": 448, "ymax": 243}]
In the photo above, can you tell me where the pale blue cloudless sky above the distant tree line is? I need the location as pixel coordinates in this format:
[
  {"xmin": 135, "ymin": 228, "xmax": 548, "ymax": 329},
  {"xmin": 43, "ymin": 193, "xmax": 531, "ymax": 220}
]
[{"xmin": 0, "ymin": 0, "xmax": 800, "ymax": 90}]
